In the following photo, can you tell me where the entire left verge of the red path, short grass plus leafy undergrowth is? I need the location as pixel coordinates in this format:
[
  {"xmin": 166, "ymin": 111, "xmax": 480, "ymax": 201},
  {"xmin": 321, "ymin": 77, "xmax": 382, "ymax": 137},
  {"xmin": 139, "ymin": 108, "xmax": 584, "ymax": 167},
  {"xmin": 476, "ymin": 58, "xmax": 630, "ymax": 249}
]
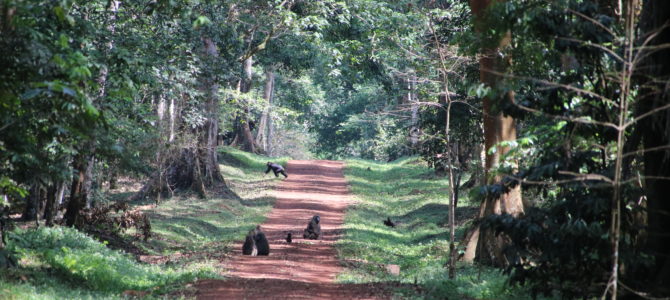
[{"xmin": 0, "ymin": 148, "xmax": 287, "ymax": 299}]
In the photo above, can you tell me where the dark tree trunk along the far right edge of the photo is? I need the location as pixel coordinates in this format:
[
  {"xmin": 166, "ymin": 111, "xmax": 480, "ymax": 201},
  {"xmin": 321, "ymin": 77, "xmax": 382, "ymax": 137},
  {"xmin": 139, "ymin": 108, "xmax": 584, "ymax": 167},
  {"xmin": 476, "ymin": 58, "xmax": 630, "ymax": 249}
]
[{"xmin": 636, "ymin": 0, "xmax": 670, "ymax": 294}]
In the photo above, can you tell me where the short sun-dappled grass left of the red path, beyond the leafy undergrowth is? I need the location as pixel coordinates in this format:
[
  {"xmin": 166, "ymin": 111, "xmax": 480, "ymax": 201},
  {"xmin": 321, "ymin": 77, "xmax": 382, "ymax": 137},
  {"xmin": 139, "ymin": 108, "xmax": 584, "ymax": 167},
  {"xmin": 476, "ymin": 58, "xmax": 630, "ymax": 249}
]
[{"xmin": 140, "ymin": 147, "xmax": 287, "ymax": 264}]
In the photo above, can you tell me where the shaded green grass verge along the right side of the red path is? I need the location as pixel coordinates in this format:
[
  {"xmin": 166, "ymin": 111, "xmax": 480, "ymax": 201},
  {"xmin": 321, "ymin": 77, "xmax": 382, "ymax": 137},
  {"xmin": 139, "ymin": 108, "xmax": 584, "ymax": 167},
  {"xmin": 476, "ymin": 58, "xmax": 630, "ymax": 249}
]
[{"xmin": 337, "ymin": 158, "xmax": 530, "ymax": 299}]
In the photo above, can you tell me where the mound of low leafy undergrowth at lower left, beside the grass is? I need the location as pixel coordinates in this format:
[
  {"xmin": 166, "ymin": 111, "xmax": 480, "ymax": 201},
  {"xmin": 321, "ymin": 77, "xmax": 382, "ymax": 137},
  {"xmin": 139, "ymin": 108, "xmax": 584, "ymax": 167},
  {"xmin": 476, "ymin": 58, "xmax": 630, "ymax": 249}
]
[{"xmin": 2, "ymin": 227, "xmax": 216, "ymax": 293}]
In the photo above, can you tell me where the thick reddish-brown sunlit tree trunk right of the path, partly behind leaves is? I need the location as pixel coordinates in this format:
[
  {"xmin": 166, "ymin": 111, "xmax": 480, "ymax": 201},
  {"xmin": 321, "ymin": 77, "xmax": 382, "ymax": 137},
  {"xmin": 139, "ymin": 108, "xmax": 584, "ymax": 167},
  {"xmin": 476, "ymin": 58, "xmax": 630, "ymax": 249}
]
[{"xmin": 463, "ymin": 0, "xmax": 524, "ymax": 266}]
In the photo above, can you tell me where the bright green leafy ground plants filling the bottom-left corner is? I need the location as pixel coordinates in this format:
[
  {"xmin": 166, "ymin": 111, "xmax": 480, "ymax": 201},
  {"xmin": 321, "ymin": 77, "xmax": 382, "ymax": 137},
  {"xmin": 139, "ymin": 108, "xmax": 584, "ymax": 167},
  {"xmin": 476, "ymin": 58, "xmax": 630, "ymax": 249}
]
[{"xmin": 2, "ymin": 227, "xmax": 217, "ymax": 299}]
